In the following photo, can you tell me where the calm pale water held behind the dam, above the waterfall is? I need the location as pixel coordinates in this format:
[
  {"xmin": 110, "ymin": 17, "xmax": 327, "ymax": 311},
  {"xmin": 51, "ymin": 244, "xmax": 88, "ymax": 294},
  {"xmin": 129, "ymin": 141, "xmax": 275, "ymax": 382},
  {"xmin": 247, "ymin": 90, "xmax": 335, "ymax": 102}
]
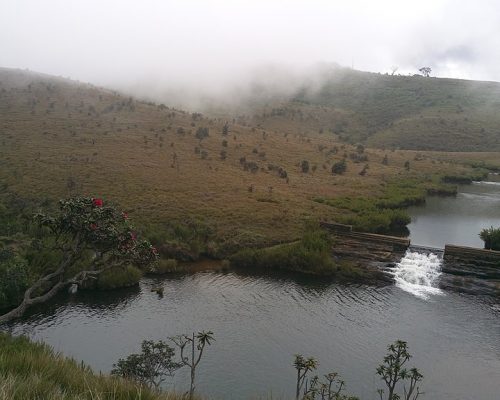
[{"xmin": 408, "ymin": 175, "xmax": 500, "ymax": 248}]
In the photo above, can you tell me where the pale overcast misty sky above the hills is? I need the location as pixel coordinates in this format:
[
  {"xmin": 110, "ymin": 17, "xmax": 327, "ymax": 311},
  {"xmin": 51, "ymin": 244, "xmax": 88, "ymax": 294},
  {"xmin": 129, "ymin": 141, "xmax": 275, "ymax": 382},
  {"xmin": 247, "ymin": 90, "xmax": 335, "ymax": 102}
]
[{"xmin": 0, "ymin": 0, "xmax": 500, "ymax": 100}]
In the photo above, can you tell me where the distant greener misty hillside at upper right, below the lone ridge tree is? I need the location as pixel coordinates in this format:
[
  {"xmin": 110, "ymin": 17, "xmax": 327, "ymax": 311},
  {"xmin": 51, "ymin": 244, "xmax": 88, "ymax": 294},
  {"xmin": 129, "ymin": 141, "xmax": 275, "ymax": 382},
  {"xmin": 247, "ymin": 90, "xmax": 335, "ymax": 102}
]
[{"xmin": 240, "ymin": 68, "xmax": 500, "ymax": 151}]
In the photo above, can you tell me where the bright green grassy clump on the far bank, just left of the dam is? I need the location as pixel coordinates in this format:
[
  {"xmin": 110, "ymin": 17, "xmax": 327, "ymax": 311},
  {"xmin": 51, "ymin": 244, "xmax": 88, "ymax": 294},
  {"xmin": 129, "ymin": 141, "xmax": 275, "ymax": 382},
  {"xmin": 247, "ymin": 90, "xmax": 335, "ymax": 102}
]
[{"xmin": 230, "ymin": 229, "xmax": 338, "ymax": 274}]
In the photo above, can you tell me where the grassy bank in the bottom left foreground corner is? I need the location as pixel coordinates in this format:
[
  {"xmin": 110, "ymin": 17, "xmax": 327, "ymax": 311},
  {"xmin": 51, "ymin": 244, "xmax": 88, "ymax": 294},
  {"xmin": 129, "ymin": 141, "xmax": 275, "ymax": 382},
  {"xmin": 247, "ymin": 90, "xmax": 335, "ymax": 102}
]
[{"xmin": 0, "ymin": 333, "xmax": 182, "ymax": 400}]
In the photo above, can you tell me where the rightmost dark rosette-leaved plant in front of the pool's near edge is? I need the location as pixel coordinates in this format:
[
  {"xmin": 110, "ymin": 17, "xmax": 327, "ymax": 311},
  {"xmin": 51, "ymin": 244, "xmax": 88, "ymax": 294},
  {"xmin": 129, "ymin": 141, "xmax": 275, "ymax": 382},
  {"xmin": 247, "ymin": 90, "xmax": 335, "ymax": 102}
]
[{"xmin": 377, "ymin": 340, "xmax": 423, "ymax": 400}]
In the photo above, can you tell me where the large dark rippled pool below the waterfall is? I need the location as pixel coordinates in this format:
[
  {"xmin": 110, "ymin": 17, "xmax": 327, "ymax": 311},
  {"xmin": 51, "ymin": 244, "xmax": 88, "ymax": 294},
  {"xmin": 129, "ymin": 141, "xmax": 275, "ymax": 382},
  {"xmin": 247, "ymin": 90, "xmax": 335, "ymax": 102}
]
[{"xmin": 4, "ymin": 272, "xmax": 500, "ymax": 400}]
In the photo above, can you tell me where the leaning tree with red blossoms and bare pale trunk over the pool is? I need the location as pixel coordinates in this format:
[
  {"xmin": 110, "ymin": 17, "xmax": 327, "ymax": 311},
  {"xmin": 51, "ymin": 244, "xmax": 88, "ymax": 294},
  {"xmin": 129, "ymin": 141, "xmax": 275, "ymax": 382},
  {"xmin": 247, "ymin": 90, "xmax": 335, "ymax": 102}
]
[{"xmin": 0, "ymin": 197, "xmax": 158, "ymax": 323}]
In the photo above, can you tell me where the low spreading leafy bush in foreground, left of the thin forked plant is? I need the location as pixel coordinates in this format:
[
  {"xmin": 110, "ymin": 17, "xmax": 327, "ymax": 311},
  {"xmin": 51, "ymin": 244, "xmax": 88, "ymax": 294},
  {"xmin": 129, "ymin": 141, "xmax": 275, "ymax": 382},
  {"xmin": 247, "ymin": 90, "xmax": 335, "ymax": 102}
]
[{"xmin": 111, "ymin": 340, "xmax": 183, "ymax": 389}]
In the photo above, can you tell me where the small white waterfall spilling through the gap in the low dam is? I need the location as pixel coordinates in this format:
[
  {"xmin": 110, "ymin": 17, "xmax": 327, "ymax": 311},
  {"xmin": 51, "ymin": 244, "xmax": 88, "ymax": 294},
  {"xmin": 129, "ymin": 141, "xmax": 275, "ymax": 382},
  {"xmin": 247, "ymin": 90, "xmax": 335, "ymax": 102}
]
[{"xmin": 391, "ymin": 249, "xmax": 442, "ymax": 299}]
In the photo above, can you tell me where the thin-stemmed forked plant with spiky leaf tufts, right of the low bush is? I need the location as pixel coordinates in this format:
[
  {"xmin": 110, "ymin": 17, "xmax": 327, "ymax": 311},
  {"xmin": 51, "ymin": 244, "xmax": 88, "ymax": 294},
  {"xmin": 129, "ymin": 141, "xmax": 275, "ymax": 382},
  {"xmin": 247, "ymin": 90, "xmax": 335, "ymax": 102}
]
[{"xmin": 171, "ymin": 331, "xmax": 215, "ymax": 399}]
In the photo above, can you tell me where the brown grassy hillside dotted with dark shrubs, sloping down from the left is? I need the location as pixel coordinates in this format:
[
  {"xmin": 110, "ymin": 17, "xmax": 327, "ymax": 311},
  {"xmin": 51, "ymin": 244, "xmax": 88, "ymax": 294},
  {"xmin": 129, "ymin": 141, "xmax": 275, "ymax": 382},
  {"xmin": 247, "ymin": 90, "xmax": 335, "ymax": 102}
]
[{"xmin": 0, "ymin": 69, "xmax": 493, "ymax": 255}]
